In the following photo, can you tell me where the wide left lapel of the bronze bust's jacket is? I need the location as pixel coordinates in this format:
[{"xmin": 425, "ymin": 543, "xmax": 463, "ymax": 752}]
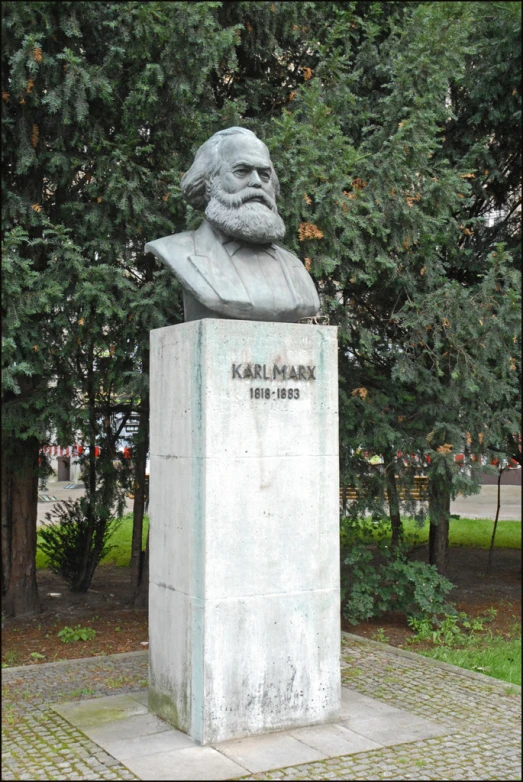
[{"xmin": 189, "ymin": 220, "xmax": 252, "ymax": 312}]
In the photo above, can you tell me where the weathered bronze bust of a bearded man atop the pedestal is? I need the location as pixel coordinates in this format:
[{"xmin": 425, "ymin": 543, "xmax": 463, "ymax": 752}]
[{"xmin": 145, "ymin": 127, "xmax": 320, "ymax": 323}]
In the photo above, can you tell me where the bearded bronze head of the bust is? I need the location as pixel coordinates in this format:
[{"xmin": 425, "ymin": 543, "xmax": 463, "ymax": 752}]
[{"xmin": 181, "ymin": 127, "xmax": 285, "ymax": 244}]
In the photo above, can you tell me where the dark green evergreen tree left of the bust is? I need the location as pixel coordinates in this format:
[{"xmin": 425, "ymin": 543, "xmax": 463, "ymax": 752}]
[{"xmin": 2, "ymin": 2, "xmax": 236, "ymax": 612}]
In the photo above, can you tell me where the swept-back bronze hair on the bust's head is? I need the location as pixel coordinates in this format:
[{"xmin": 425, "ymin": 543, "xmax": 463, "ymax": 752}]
[{"xmin": 181, "ymin": 127, "xmax": 280, "ymax": 209}]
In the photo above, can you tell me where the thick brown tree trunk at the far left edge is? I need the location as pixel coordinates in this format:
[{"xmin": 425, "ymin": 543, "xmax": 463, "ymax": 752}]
[{"xmin": 2, "ymin": 437, "xmax": 40, "ymax": 616}]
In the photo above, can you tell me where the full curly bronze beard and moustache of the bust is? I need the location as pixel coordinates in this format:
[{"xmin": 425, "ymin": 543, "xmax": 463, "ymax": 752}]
[{"xmin": 205, "ymin": 177, "xmax": 285, "ymax": 244}]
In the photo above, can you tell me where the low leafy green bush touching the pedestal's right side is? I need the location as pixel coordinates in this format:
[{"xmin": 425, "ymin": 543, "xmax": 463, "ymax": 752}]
[{"xmin": 341, "ymin": 520, "xmax": 454, "ymax": 624}]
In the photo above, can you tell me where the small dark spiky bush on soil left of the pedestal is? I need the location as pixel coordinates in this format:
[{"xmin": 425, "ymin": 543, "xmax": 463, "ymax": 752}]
[{"xmin": 37, "ymin": 497, "xmax": 119, "ymax": 592}]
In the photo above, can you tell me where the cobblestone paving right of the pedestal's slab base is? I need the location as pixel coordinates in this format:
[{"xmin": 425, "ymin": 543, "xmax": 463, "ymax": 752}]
[{"xmin": 241, "ymin": 635, "xmax": 521, "ymax": 780}]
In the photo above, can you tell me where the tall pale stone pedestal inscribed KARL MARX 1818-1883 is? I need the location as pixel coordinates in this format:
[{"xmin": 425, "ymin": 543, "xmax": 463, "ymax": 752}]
[{"xmin": 149, "ymin": 319, "xmax": 340, "ymax": 744}]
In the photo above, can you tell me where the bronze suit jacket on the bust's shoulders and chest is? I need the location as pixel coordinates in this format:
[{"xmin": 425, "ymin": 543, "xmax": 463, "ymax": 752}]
[{"xmin": 145, "ymin": 220, "xmax": 320, "ymax": 323}]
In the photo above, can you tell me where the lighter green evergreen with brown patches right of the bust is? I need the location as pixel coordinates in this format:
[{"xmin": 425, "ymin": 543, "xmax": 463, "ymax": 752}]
[{"xmin": 260, "ymin": 3, "xmax": 520, "ymax": 572}]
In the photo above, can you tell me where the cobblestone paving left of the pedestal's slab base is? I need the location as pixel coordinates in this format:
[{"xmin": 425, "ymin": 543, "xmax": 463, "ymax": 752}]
[{"xmin": 2, "ymin": 652, "xmax": 148, "ymax": 780}]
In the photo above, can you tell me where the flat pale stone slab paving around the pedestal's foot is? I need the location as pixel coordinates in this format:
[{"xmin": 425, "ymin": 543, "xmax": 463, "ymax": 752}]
[{"xmin": 51, "ymin": 687, "xmax": 448, "ymax": 779}]
